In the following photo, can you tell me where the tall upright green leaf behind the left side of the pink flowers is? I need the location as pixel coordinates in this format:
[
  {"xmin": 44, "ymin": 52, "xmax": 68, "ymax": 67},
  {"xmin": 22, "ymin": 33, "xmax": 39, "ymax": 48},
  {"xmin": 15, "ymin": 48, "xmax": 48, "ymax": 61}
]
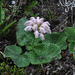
[{"xmin": 16, "ymin": 18, "xmax": 34, "ymax": 46}]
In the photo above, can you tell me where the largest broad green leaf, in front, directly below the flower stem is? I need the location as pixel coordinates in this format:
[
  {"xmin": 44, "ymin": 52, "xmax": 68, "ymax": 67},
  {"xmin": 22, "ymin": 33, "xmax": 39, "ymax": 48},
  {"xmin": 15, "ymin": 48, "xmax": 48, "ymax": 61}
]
[{"xmin": 28, "ymin": 44, "xmax": 61, "ymax": 64}]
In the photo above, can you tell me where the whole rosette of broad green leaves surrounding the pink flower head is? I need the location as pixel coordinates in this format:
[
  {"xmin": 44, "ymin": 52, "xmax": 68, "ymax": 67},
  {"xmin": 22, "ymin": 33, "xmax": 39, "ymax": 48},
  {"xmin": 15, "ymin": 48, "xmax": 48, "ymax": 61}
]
[{"xmin": 4, "ymin": 18, "xmax": 67, "ymax": 67}]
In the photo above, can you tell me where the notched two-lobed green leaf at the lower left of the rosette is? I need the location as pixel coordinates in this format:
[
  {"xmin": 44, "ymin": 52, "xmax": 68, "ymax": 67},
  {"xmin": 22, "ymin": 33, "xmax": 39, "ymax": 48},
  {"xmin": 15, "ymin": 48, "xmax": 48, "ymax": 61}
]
[{"xmin": 4, "ymin": 45, "xmax": 29, "ymax": 67}]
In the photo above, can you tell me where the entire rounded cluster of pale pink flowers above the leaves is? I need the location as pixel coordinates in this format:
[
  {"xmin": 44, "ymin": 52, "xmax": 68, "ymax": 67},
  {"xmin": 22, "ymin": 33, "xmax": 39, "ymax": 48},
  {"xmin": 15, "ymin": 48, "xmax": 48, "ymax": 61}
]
[{"xmin": 24, "ymin": 17, "xmax": 51, "ymax": 40}]
